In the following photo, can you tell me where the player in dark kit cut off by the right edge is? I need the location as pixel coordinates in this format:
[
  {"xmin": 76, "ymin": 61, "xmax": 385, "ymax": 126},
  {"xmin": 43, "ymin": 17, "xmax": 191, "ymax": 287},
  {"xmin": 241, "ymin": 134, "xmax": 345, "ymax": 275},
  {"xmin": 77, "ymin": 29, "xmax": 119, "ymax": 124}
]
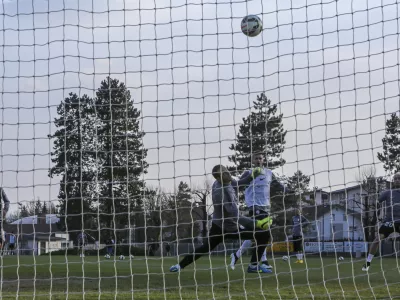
[{"xmin": 362, "ymin": 172, "xmax": 400, "ymax": 272}]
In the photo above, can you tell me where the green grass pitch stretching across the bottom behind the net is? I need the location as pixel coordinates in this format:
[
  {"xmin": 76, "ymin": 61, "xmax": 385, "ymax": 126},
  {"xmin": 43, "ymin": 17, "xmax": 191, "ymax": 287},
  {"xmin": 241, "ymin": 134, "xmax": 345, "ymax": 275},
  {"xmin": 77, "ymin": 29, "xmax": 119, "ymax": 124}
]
[{"xmin": 0, "ymin": 256, "xmax": 400, "ymax": 300}]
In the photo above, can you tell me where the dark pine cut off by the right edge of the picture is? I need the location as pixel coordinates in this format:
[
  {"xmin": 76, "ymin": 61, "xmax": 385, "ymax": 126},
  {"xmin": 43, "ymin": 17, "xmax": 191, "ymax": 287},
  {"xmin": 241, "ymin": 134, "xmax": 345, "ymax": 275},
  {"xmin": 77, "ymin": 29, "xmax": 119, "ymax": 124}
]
[{"xmin": 378, "ymin": 113, "xmax": 400, "ymax": 175}]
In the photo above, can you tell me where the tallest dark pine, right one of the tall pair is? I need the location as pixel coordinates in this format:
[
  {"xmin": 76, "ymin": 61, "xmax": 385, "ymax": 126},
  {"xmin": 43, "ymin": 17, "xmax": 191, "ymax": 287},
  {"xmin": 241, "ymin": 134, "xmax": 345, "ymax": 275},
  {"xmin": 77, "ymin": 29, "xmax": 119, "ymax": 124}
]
[{"xmin": 94, "ymin": 77, "xmax": 148, "ymax": 236}]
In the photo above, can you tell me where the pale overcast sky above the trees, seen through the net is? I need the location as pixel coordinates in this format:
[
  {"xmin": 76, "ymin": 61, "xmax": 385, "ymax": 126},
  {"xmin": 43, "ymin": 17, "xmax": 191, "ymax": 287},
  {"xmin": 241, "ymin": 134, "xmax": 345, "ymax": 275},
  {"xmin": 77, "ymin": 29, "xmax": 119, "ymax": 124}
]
[{"xmin": 0, "ymin": 0, "xmax": 400, "ymax": 211}]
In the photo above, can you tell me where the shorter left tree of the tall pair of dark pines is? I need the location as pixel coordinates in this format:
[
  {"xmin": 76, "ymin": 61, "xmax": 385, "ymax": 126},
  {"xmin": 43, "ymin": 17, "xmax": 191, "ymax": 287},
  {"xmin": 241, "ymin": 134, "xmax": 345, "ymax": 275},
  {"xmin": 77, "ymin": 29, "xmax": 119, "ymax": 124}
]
[{"xmin": 49, "ymin": 93, "xmax": 96, "ymax": 239}]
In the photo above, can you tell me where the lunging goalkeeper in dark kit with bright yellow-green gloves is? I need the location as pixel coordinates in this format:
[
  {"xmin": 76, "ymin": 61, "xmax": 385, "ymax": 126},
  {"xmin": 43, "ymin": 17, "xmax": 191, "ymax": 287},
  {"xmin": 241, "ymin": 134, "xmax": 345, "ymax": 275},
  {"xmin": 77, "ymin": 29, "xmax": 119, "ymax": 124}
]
[{"xmin": 170, "ymin": 165, "xmax": 272, "ymax": 273}]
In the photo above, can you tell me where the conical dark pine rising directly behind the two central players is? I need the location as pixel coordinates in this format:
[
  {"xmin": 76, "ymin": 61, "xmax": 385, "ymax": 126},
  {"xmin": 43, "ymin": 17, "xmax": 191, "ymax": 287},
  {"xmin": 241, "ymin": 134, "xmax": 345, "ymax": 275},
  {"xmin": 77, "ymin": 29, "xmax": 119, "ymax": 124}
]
[{"xmin": 228, "ymin": 93, "xmax": 286, "ymax": 175}]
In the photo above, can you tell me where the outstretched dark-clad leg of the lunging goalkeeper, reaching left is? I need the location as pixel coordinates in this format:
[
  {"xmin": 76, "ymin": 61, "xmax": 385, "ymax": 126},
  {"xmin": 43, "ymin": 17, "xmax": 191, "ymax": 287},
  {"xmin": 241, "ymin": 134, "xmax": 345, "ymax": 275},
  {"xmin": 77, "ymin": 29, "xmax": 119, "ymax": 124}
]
[{"xmin": 169, "ymin": 224, "xmax": 223, "ymax": 272}]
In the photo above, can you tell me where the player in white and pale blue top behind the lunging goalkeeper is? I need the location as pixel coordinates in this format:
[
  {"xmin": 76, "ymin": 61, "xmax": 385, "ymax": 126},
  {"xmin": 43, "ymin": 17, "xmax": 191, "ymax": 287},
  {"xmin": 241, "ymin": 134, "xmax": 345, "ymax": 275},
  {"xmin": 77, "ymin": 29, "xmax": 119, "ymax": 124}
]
[{"xmin": 230, "ymin": 153, "xmax": 285, "ymax": 270}]
